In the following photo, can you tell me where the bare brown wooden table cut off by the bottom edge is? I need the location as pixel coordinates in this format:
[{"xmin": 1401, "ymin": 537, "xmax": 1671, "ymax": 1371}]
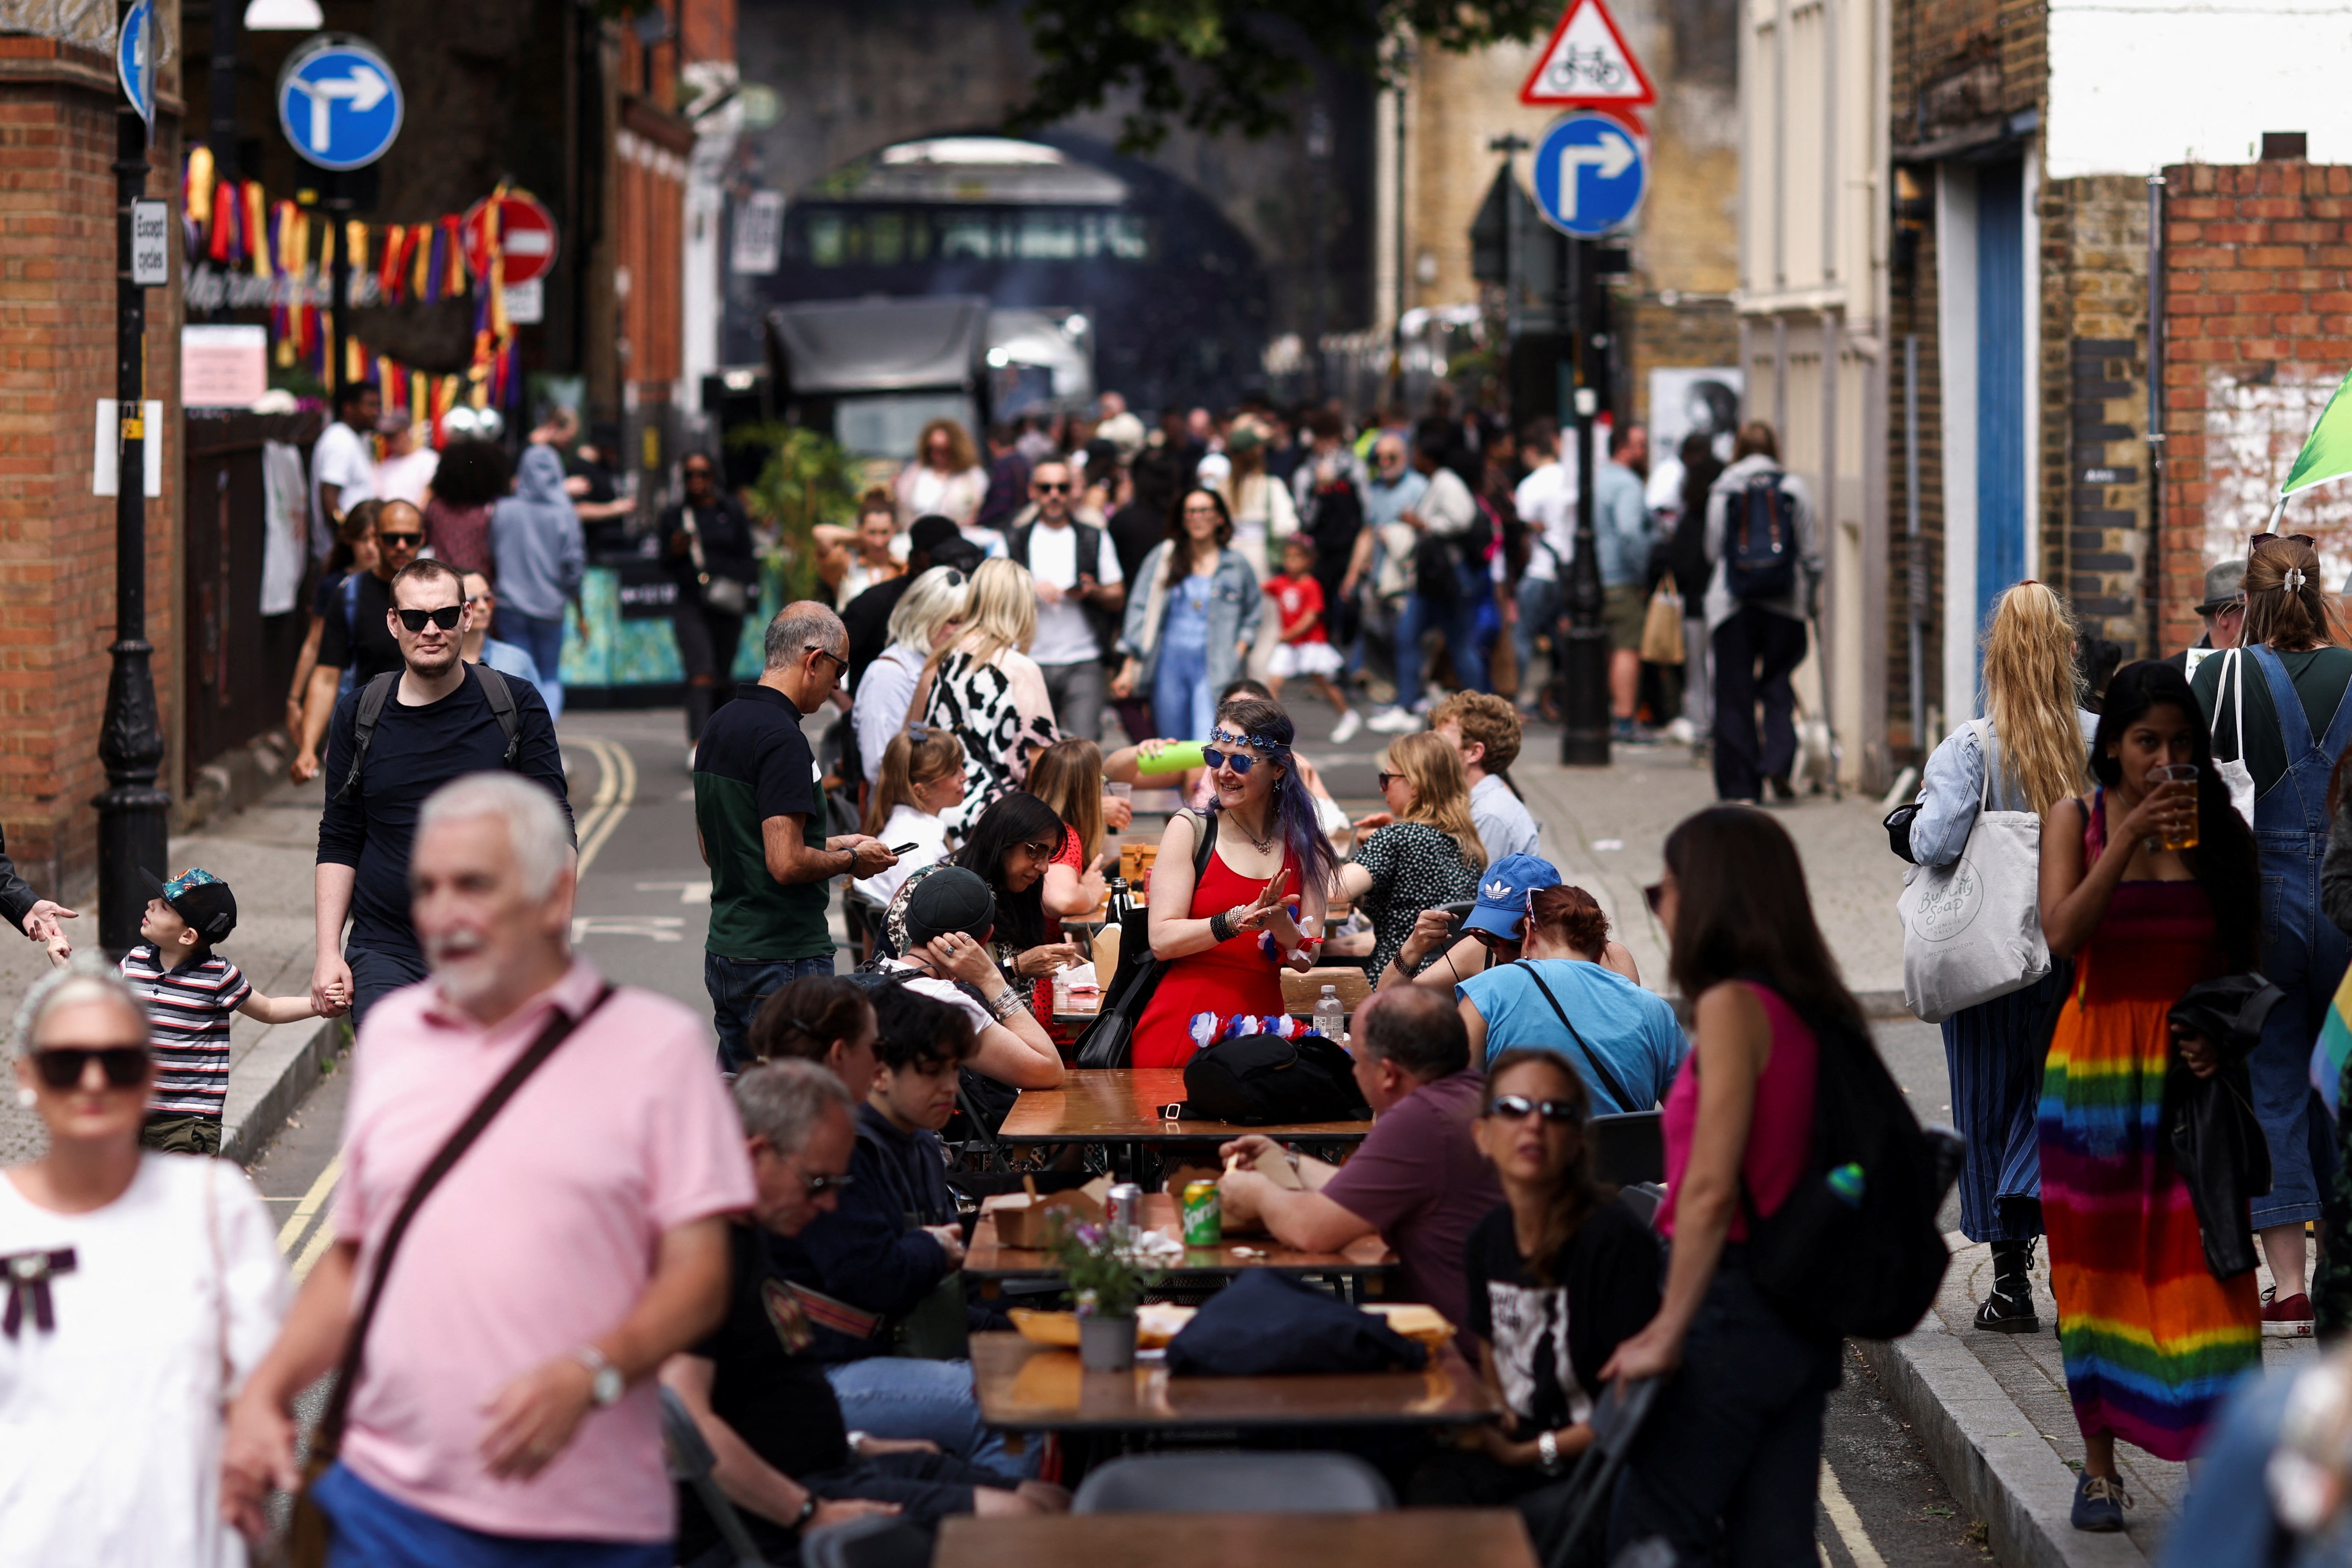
[{"xmin": 936, "ymin": 1509, "xmax": 1536, "ymax": 1568}]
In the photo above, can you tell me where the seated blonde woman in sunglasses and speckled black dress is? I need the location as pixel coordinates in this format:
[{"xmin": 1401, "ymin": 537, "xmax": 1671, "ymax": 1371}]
[{"xmin": 1339, "ymin": 729, "xmax": 1486, "ymax": 980}]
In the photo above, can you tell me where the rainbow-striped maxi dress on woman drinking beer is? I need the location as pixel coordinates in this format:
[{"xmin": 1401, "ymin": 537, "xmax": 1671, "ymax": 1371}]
[{"xmin": 2039, "ymin": 792, "xmax": 2263, "ymax": 1460}]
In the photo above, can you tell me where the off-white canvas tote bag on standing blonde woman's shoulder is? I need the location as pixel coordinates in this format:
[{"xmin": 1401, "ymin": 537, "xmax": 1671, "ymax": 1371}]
[{"xmin": 1896, "ymin": 719, "xmax": 2051, "ymax": 1023}]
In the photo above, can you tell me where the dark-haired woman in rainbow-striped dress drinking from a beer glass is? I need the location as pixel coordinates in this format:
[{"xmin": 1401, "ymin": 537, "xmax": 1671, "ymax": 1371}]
[{"xmin": 2042, "ymin": 663, "xmax": 2263, "ymax": 1530}]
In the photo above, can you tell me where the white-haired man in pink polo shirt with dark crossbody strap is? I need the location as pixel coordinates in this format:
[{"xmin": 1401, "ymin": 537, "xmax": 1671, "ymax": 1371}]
[{"xmin": 224, "ymin": 774, "xmax": 755, "ymax": 1568}]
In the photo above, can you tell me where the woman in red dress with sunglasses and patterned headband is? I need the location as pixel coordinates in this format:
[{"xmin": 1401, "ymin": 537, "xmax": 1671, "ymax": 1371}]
[{"xmin": 1134, "ymin": 698, "xmax": 1339, "ymax": 1067}]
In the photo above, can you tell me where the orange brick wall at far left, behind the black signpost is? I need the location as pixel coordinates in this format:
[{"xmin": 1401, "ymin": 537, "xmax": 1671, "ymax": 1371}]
[{"xmin": 0, "ymin": 38, "xmax": 181, "ymax": 896}]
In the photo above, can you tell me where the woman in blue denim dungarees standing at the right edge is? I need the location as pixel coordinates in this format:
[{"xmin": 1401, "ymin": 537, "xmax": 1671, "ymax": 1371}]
[{"xmin": 2192, "ymin": 534, "xmax": 2352, "ymax": 1335}]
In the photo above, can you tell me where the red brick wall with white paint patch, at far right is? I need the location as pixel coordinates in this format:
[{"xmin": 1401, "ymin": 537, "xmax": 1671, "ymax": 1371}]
[{"xmin": 2159, "ymin": 160, "xmax": 2352, "ymax": 649}]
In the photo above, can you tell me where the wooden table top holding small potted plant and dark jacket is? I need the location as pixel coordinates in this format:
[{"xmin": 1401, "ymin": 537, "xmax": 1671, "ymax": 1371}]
[{"xmin": 972, "ymin": 1333, "xmax": 1501, "ymax": 1432}]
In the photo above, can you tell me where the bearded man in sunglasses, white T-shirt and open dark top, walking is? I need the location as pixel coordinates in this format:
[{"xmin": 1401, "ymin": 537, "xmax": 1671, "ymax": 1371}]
[{"xmin": 1007, "ymin": 458, "xmax": 1127, "ymax": 741}]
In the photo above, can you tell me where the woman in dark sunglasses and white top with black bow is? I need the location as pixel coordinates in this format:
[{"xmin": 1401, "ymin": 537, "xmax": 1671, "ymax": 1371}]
[{"xmin": 0, "ymin": 969, "xmax": 287, "ymax": 1568}]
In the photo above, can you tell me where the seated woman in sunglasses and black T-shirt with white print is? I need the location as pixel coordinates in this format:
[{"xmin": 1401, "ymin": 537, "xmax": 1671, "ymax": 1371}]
[{"xmin": 1411, "ymin": 1051, "xmax": 1658, "ymax": 1561}]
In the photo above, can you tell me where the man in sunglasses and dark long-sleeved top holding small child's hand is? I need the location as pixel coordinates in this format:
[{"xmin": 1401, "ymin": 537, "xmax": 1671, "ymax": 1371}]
[{"xmin": 310, "ymin": 557, "xmax": 572, "ymax": 1023}]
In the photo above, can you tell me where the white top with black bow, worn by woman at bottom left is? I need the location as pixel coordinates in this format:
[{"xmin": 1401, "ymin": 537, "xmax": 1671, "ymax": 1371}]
[{"xmin": 0, "ymin": 1152, "xmax": 287, "ymax": 1568}]
